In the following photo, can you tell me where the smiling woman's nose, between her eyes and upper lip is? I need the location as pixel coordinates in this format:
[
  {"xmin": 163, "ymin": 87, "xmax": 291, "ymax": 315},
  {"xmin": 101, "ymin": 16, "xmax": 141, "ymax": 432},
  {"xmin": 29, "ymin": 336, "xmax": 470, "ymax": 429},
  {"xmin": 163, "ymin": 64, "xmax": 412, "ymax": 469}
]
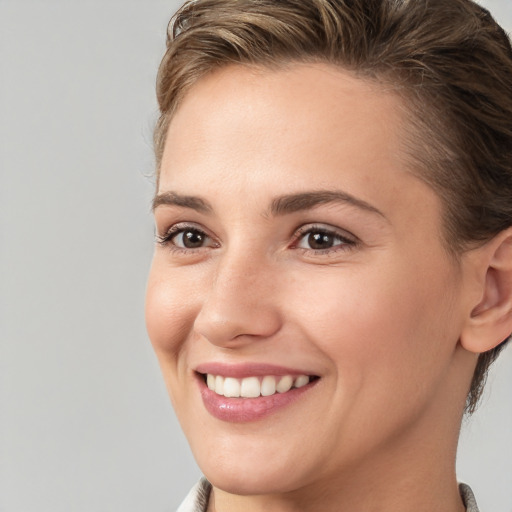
[{"xmin": 194, "ymin": 252, "xmax": 281, "ymax": 348}]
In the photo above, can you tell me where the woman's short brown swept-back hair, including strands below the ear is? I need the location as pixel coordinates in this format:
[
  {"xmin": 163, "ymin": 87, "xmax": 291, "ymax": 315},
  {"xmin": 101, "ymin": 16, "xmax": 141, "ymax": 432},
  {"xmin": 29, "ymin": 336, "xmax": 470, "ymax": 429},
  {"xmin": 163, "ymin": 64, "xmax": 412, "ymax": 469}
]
[{"xmin": 154, "ymin": 0, "xmax": 512, "ymax": 413}]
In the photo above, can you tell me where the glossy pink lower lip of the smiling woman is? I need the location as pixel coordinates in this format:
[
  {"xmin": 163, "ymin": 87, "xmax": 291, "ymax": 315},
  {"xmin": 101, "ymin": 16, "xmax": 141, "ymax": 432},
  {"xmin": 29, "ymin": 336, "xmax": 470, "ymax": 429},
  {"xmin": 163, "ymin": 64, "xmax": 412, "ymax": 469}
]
[{"xmin": 199, "ymin": 376, "xmax": 318, "ymax": 423}]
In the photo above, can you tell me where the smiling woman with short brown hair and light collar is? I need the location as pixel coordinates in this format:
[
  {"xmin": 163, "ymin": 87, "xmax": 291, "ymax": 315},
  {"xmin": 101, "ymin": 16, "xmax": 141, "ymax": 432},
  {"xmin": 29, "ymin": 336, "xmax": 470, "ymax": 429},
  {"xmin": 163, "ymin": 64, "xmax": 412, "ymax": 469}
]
[{"xmin": 147, "ymin": 0, "xmax": 512, "ymax": 512}]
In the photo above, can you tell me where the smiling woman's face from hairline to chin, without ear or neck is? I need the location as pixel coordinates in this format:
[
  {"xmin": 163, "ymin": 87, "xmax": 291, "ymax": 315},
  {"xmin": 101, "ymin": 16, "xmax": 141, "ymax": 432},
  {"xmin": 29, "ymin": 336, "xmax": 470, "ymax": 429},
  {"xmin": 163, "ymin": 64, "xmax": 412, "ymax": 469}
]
[{"xmin": 146, "ymin": 64, "xmax": 474, "ymax": 494}]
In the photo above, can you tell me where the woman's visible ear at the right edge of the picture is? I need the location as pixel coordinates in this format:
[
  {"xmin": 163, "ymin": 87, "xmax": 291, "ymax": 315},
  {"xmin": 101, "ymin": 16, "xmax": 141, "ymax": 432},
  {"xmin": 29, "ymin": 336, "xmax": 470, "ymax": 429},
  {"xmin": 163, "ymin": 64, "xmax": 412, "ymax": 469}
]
[{"xmin": 460, "ymin": 228, "xmax": 512, "ymax": 354}]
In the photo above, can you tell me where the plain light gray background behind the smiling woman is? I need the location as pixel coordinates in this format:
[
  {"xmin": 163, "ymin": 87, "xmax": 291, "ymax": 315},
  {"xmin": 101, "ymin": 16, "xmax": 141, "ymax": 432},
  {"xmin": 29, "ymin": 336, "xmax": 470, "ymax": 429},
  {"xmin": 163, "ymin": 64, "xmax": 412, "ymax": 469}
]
[{"xmin": 0, "ymin": 0, "xmax": 512, "ymax": 512}]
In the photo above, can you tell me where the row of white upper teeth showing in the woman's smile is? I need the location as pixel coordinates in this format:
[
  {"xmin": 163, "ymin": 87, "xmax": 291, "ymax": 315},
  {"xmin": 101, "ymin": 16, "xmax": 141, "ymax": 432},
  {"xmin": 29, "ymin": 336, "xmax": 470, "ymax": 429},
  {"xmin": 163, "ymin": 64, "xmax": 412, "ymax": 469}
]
[{"xmin": 206, "ymin": 373, "xmax": 309, "ymax": 398}]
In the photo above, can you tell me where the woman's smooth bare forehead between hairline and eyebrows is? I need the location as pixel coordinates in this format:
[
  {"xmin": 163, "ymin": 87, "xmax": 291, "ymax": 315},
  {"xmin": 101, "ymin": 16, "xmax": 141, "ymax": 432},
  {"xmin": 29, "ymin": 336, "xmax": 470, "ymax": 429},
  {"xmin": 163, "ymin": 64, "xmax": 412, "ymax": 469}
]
[{"xmin": 159, "ymin": 64, "xmax": 428, "ymax": 216}]
